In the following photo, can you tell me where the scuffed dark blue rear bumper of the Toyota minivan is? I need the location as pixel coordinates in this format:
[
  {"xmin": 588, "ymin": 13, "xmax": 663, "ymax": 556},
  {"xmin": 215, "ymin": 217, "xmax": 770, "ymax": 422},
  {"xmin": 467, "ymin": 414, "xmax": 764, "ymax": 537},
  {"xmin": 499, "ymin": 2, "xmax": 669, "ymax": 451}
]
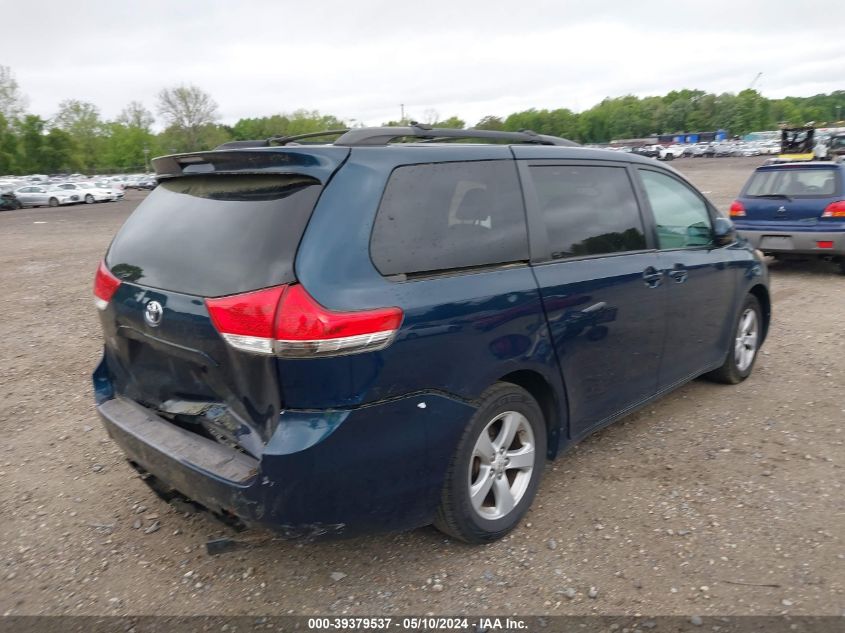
[{"xmin": 97, "ymin": 382, "xmax": 474, "ymax": 537}]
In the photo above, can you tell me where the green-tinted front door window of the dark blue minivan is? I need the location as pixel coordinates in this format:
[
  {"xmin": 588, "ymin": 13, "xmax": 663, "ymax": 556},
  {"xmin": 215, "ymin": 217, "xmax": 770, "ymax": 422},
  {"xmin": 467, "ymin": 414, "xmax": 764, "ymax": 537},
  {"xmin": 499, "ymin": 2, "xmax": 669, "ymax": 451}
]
[{"xmin": 640, "ymin": 170, "xmax": 713, "ymax": 249}]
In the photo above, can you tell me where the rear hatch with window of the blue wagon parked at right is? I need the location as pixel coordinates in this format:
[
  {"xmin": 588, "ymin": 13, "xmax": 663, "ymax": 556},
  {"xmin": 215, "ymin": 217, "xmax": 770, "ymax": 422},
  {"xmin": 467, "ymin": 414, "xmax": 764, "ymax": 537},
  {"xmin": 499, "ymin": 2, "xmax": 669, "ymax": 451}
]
[{"xmin": 736, "ymin": 163, "xmax": 842, "ymax": 230}]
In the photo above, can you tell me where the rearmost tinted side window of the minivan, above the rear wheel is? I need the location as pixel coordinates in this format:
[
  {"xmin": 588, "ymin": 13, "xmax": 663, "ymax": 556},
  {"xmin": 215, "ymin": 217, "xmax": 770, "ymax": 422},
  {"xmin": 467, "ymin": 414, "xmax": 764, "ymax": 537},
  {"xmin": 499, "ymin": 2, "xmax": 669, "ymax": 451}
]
[{"xmin": 370, "ymin": 161, "xmax": 528, "ymax": 276}]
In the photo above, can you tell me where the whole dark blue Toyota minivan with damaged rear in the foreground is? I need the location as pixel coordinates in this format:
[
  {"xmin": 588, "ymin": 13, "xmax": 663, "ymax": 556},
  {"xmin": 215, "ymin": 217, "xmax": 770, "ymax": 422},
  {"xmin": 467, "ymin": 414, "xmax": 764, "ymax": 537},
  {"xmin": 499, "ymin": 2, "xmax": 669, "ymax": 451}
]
[{"xmin": 93, "ymin": 125, "xmax": 771, "ymax": 543}]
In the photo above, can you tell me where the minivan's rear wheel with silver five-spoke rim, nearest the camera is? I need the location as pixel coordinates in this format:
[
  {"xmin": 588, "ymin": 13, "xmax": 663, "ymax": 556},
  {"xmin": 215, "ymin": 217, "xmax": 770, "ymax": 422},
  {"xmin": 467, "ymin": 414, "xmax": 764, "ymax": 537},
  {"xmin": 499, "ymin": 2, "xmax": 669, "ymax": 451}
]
[{"xmin": 434, "ymin": 383, "xmax": 546, "ymax": 543}]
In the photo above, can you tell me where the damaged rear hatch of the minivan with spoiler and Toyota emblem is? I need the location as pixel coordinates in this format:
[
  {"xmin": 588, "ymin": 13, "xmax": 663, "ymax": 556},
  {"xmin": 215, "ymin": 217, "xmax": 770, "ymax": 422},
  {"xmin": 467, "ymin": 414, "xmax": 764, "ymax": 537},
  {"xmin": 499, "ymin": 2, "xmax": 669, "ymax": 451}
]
[{"xmin": 98, "ymin": 147, "xmax": 349, "ymax": 457}]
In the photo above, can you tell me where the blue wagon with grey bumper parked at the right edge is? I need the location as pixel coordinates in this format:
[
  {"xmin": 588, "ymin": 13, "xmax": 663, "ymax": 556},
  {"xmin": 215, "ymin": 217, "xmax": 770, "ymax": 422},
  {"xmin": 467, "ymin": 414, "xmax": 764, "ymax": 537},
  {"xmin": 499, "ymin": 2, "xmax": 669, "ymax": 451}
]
[{"xmin": 730, "ymin": 161, "xmax": 845, "ymax": 273}]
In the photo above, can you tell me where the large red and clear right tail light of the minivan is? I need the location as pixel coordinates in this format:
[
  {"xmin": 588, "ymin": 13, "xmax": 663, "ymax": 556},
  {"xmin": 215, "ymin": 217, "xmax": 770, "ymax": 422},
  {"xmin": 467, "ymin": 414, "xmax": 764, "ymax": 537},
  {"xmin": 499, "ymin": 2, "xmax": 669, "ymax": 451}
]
[{"xmin": 205, "ymin": 284, "xmax": 403, "ymax": 358}]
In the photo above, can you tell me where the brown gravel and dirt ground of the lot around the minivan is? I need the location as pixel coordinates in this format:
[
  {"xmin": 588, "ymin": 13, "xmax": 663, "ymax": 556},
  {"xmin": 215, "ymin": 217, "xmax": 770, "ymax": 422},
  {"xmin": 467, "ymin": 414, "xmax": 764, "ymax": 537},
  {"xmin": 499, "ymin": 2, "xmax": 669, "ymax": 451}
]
[{"xmin": 0, "ymin": 158, "xmax": 845, "ymax": 616}]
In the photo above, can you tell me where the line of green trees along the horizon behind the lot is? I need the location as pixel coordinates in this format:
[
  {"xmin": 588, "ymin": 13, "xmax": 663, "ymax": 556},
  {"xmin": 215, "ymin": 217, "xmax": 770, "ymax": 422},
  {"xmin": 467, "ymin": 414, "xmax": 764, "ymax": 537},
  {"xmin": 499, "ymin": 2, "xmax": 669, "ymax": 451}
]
[{"xmin": 0, "ymin": 66, "xmax": 845, "ymax": 175}]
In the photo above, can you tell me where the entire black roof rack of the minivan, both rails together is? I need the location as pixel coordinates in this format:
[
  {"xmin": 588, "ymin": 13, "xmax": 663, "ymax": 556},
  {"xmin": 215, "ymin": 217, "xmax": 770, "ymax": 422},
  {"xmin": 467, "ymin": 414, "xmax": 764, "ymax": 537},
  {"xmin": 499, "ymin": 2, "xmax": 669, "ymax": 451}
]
[{"xmin": 215, "ymin": 123, "xmax": 578, "ymax": 149}]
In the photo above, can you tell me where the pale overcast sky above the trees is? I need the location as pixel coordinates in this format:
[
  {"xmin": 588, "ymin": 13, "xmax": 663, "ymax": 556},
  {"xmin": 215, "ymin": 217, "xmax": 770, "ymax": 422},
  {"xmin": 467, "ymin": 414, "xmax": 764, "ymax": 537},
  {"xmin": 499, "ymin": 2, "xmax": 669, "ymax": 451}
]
[{"xmin": 0, "ymin": 0, "xmax": 845, "ymax": 124}]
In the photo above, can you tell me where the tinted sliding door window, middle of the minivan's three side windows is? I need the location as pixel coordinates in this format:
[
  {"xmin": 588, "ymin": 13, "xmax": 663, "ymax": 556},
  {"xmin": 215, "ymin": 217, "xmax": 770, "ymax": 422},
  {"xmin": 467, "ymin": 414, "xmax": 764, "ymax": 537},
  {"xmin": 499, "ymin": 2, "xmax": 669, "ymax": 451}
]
[{"xmin": 529, "ymin": 165, "xmax": 646, "ymax": 259}]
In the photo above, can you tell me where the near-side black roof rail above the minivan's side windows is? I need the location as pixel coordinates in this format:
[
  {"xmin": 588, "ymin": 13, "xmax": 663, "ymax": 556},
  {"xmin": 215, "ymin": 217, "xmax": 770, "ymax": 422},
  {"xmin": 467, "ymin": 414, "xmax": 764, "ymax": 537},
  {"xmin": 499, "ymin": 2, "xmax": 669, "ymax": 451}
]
[{"xmin": 334, "ymin": 123, "xmax": 578, "ymax": 147}]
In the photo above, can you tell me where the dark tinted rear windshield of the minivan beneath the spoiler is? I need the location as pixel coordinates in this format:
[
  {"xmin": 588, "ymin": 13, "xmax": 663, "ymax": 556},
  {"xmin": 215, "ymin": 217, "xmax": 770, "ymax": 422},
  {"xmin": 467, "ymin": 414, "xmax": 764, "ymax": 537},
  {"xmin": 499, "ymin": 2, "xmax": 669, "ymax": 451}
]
[{"xmin": 106, "ymin": 174, "xmax": 321, "ymax": 297}]
